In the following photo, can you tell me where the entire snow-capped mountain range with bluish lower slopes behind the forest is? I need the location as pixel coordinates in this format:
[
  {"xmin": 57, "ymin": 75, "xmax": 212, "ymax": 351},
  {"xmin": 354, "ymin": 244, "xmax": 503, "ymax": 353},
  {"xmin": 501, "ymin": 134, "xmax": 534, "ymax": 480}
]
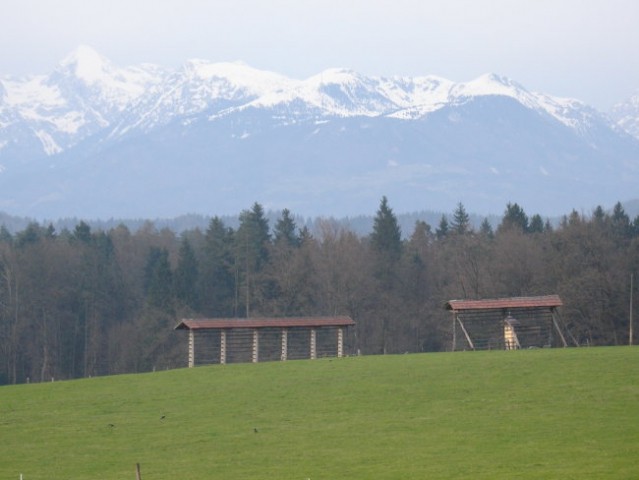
[{"xmin": 0, "ymin": 47, "xmax": 639, "ymax": 218}]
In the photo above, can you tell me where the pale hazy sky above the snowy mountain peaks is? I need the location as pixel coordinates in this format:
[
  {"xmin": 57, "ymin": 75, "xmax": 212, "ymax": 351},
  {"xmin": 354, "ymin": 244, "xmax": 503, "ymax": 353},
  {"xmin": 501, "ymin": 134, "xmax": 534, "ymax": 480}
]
[{"xmin": 0, "ymin": 0, "xmax": 639, "ymax": 110}]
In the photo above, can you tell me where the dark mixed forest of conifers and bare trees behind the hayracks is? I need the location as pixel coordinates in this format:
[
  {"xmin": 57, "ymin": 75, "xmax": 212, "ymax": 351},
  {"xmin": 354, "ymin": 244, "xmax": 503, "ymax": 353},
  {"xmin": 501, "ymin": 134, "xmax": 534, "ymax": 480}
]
[{"xmin": 0, "ymin": 197, "xmax": 639, "ymax": 384}]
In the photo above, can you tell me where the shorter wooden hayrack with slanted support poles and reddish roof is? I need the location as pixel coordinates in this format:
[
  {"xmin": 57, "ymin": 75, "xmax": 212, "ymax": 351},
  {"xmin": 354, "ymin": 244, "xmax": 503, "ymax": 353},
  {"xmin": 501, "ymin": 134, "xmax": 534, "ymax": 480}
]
[{"xmin": 445, "ymin": 295, "xmax": 574, "ymax": 351}]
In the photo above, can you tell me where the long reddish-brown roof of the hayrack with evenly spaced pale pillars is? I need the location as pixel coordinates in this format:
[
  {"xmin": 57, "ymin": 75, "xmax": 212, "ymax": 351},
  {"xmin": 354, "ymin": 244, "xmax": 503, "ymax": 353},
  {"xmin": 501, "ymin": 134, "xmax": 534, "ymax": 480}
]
[{"xmin": 175, "ymin": 316, "xmax": 355, "ymax": 330}]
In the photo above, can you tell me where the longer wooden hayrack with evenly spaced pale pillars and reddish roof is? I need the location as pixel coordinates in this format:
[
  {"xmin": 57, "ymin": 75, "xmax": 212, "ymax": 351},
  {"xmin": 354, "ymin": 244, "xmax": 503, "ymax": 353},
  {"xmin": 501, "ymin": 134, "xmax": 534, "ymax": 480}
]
[{"xmin": 175, "ymin": 316, "xmax": 355, "ymax": 367}]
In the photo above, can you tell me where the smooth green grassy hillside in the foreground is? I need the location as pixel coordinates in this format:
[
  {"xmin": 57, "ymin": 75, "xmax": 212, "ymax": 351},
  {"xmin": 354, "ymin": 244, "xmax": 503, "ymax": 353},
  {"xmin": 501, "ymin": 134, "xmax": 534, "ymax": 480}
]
[{"xmin": 0, "ymin": 347, "xmax": 639, "ymax": 480}]
